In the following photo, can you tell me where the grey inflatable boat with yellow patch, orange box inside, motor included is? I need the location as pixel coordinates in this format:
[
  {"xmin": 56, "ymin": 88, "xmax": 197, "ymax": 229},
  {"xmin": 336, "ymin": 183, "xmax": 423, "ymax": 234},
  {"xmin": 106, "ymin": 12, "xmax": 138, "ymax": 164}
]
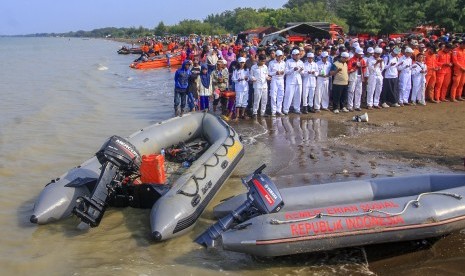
[{"xmin": 30, "ymin": 113, "xmax": 244, "ymax": 241}]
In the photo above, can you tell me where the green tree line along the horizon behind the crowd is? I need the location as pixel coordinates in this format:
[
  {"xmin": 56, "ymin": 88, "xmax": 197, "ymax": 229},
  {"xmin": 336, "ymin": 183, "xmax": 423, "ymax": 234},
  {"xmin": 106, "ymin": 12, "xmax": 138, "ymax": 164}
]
[{"xmin": 27, "ymin": 0, "xmax": 465, "ymax": 38}]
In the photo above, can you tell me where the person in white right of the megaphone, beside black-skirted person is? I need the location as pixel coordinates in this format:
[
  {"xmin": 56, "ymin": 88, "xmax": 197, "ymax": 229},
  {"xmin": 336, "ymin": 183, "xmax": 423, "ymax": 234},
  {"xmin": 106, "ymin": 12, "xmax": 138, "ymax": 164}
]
[{"xmin": 367, "ymin": 47, "xmax": 384, "ymax": 109}]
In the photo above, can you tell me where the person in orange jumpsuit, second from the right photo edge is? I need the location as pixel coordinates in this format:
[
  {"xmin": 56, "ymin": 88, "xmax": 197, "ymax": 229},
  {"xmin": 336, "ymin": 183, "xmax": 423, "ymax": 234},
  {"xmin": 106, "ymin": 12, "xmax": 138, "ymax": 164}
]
[{"xmin": 434, "ymin": 43, "xmax": 453, "ymax": 102}]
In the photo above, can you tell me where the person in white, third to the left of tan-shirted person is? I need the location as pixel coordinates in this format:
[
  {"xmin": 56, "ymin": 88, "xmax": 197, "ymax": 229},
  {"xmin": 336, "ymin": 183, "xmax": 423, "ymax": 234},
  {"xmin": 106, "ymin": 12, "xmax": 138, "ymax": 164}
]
[{"xmin": 283, "ymin": 49, "xmax": 304, "ymax": 115}]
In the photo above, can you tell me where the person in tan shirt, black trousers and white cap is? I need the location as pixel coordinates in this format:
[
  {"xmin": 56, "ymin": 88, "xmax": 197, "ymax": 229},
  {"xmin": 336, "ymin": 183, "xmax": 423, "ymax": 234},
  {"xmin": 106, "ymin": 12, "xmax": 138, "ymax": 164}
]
[{"xmin": 330, "ymin": 52, "xmax": 349, "ymax": 114}]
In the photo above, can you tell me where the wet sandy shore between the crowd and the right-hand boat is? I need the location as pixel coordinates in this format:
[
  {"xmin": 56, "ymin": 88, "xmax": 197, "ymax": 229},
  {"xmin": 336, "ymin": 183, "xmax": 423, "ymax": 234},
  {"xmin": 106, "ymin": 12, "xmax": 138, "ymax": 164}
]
[{"xmin": 227, "ymin": 102, "xmax": 465, "ymax": 185}]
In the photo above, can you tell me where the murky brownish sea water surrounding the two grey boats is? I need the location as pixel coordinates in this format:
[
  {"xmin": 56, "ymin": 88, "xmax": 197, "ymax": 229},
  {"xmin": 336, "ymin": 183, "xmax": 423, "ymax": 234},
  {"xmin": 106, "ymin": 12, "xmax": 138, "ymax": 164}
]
[{"xmin": 0, "ymin": 38, "xmax": 465, "ymax": 276}]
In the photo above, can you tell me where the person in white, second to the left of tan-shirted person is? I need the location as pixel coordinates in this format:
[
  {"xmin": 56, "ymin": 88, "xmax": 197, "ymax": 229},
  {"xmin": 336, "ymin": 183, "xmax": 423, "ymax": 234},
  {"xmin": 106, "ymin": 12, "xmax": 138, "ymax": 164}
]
[{"xmin": 302, "ymin": 53, "xmax": 318, "ymax": 114}]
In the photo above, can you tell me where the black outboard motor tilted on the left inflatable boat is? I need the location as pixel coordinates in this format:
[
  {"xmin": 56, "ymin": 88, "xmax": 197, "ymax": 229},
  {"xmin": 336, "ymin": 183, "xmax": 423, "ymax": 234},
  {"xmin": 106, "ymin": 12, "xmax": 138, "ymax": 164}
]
[{"xmin": 73, "ymin": 135, "xmax": 141, "ymax": 227}]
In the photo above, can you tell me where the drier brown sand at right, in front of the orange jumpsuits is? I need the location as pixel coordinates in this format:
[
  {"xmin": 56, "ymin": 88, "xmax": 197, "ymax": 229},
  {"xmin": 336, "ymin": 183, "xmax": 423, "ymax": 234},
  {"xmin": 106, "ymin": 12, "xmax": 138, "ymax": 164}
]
[{"xmin": 330, "ymin": 102, "xmax": 465, "ymax": 170}]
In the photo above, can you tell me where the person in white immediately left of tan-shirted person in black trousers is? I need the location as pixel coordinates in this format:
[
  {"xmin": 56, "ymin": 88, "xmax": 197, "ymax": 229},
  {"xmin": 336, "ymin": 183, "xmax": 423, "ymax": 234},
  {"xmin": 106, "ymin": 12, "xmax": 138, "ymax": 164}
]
[{"xmin": 314, "ymin": 51, "xmax": 332, "ymax": 112}]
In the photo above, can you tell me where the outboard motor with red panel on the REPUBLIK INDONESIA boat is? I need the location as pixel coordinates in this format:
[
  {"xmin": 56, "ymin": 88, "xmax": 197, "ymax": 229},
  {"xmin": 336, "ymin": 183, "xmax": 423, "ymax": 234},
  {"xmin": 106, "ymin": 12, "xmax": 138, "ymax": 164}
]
[{"xmin": 195, "ymin": 164, "xmax": 284, "ymax": 247}]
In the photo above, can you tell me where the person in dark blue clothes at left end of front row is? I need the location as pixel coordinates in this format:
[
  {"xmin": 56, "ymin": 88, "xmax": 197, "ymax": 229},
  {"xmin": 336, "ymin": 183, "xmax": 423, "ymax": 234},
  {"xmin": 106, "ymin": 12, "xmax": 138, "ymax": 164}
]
[{"xmin": 174, "ymin": 60, "xmax": 192, "ymax": 117}]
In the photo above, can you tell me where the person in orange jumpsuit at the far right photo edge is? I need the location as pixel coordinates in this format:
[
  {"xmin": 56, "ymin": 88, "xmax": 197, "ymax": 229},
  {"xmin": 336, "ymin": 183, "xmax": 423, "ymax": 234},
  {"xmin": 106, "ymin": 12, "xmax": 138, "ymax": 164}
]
[{"xmin": 450, "ymin": 41, "xmax": 465, "ymax": 102}]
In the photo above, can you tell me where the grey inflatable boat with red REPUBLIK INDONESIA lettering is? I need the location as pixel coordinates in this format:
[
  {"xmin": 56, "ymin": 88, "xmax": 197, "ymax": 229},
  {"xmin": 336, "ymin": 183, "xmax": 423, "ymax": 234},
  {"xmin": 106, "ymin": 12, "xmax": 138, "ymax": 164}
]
[{"xmin": 209, "ymin": 174, "xmax": 465, "ymax": 256}]
